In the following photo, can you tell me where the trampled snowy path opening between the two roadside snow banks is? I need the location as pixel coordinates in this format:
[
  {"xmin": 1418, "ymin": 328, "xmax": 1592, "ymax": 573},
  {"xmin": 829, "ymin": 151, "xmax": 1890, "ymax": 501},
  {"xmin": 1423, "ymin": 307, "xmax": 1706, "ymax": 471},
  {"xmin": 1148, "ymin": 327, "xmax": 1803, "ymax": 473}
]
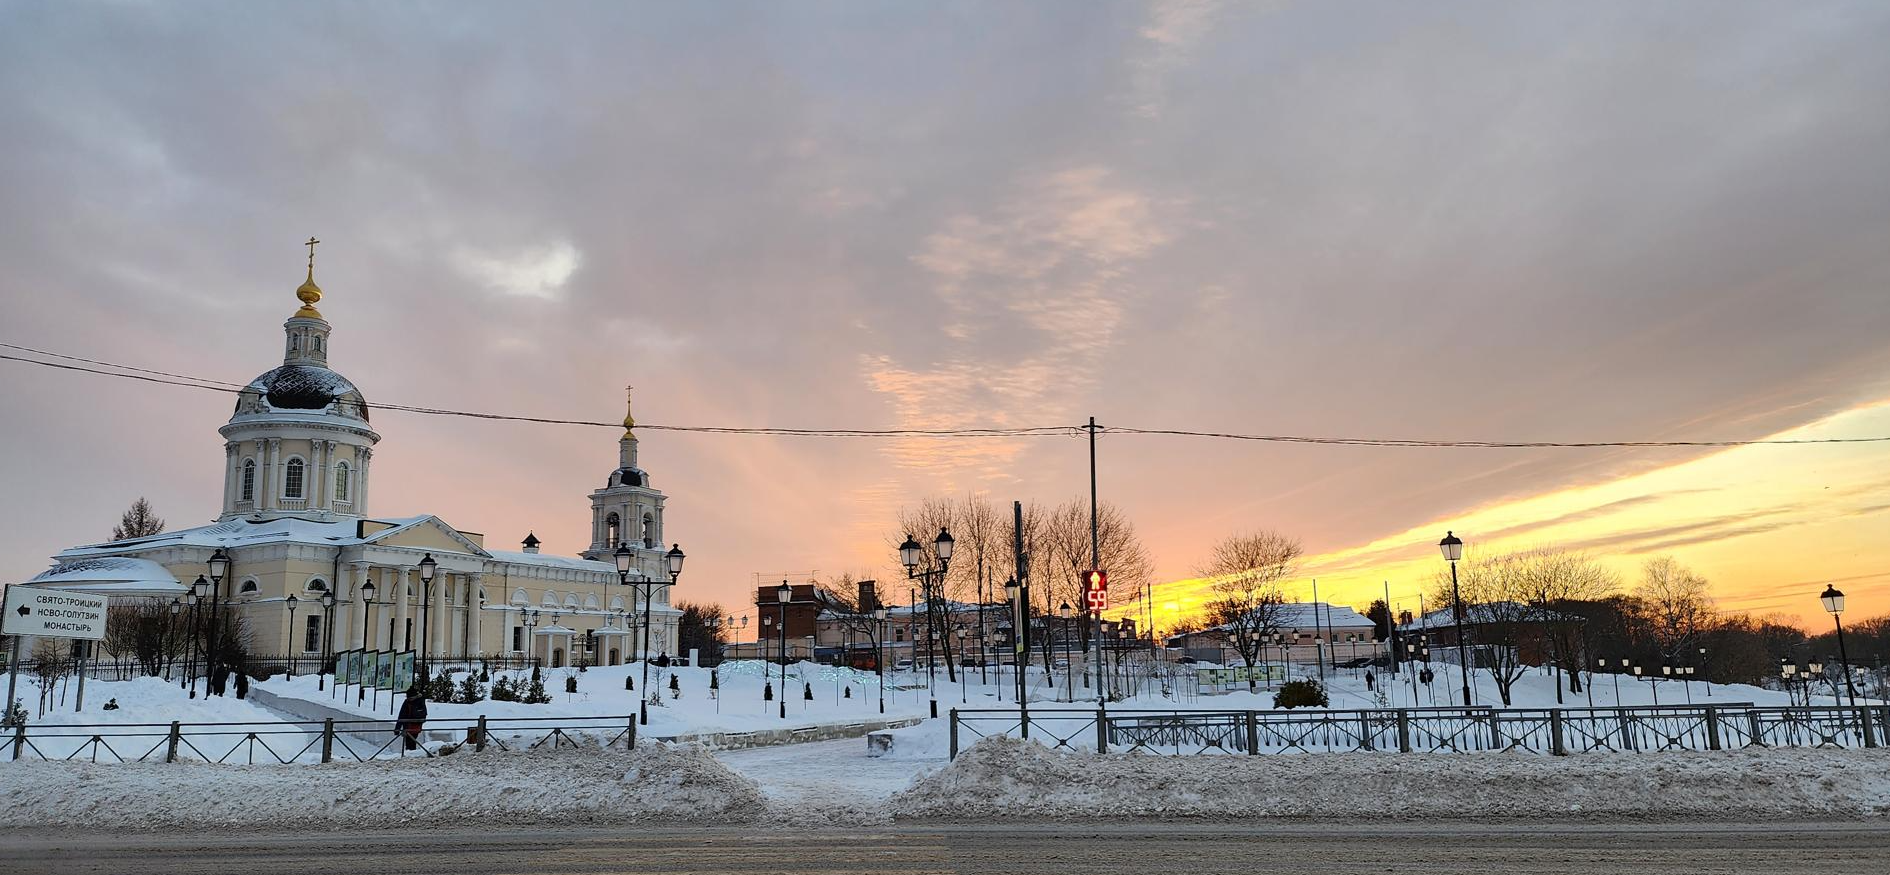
[{"xmin": 714, "ymin": 739, "xmax": 945, "ymax": 822}]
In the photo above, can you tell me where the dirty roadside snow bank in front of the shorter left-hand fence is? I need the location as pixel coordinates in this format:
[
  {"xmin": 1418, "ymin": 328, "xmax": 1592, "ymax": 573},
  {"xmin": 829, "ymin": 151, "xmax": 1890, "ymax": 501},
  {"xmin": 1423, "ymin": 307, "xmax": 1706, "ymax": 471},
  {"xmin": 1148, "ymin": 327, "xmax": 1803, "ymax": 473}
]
[{"xmin": 0, "ymin": 745, "xmax": 764, "ymax": 830}]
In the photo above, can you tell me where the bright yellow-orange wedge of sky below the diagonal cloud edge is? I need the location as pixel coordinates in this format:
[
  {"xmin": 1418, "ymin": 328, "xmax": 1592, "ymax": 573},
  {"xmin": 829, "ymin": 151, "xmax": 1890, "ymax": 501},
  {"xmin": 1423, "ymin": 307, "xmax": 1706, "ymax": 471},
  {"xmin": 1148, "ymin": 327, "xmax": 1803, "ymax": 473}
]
[{"xmin": 1111, "ymin": 399, "xmax": 1890, "ymax": 633}]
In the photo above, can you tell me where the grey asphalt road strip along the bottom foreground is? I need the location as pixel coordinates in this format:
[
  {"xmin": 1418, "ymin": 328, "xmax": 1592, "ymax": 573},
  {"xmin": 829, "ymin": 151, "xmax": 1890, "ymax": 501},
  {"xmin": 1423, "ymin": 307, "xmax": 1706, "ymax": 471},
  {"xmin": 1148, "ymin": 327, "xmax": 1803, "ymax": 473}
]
[{"xmin": 0, "ymin": 822, "xmax": 1890, "ymax": 875}]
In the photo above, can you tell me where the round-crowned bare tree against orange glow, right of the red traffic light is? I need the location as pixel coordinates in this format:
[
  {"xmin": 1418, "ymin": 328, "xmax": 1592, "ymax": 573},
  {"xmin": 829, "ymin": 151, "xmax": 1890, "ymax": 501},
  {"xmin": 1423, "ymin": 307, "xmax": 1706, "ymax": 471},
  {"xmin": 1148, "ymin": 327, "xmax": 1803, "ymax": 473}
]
[{"xmin": 1196, "ymin": 531, "xmax": 1300, "ymax": 692}]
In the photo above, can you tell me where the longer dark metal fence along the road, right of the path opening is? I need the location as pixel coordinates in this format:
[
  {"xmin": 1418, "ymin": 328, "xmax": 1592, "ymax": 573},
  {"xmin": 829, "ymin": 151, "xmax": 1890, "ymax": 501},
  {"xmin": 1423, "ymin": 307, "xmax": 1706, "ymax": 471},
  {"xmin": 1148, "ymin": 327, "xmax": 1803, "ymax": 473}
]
[{"xmin": 951, "ymin": 705, "xmax": 1890, "ymax": 758}]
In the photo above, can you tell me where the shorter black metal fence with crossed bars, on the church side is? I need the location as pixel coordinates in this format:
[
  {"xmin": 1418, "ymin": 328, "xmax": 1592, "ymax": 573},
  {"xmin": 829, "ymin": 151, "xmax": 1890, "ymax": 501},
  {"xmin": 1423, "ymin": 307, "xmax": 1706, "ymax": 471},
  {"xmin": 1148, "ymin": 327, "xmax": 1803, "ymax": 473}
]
[{"xmin": 0, "ymin": 714, "xmax": 637, "ymax": 765}]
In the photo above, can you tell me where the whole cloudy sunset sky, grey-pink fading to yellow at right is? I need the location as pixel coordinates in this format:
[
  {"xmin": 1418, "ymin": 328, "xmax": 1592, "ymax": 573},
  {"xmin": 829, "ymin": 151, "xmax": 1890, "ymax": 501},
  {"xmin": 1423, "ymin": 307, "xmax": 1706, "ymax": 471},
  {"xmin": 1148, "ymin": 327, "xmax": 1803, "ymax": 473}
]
[{"xmin": 11, "ymin": 0, "xmax": 1890, "ymax": 629}]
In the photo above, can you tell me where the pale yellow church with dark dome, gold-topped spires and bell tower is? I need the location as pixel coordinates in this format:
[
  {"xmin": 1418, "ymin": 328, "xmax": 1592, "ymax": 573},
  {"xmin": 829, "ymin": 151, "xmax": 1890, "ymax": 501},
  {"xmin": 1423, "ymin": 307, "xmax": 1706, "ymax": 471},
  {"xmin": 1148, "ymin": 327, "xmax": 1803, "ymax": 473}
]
[{"xmin": 28, "ymin": 249, "xmax": 680, "ymax": 667}]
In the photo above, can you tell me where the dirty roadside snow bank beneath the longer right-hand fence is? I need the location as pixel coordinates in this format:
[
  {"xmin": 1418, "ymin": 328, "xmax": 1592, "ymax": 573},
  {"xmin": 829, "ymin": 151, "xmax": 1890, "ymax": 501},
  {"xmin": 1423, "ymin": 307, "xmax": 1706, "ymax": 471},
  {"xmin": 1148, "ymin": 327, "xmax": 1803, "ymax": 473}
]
[{"xmin": 890, "ymin": 737, "xmax": 1890, "ymax": 820}]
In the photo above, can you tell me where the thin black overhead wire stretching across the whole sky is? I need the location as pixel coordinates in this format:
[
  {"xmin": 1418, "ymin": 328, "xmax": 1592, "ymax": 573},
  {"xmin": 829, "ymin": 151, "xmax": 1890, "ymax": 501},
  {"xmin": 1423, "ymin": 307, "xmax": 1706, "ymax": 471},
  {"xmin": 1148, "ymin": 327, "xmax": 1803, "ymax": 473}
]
[{"xmin": 0, "ymin": 342, "xmax": 1890, "ymax": 450}]
